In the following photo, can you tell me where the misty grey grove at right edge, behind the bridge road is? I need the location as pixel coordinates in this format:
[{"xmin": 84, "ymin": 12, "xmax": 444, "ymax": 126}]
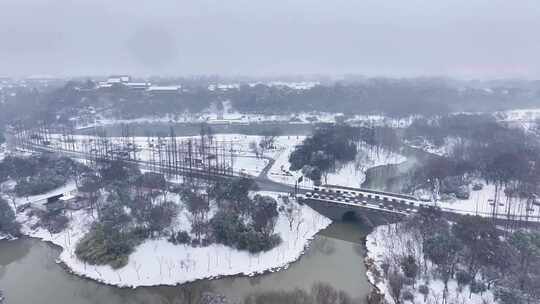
[{"xmin": 402, "ymin": 114, "xmax": 540, "ymax": 214}]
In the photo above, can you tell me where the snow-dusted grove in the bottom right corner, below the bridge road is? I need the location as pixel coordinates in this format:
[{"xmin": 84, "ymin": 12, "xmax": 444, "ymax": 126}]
[{"xmin": 380, "ymin": 209, "xmax": 540, "ymax": 304}]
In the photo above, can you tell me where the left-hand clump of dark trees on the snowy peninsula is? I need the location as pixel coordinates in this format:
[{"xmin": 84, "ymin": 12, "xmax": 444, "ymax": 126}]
[{"xmin": 75, "ymin": 160, "xmax": 178, "ymax": 268}]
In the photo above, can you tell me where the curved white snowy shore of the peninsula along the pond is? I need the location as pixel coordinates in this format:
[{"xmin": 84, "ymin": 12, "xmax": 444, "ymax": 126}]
[{"xmin": 17, "ymin": 192, "xmax": 331, "ymax": 287}]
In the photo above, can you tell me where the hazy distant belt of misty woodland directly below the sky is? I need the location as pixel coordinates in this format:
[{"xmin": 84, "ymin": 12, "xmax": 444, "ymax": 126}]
[{"xmin": 0, "ymin": 78, "xmax": 540, "ymax": 129}]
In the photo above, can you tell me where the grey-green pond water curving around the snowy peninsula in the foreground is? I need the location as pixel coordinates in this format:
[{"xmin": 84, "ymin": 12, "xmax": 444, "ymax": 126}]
[{"xmin": 0, "ymin": 223, "xmax": 370, "ymax": 304}]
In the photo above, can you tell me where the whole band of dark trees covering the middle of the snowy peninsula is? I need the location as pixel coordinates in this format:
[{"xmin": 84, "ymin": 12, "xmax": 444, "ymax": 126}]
[{"xmin": 75, "ymin": 161, "xmax": 281, "ymax": 268}]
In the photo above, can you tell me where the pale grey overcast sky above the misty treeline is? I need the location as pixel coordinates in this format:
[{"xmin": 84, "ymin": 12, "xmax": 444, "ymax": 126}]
[{"xmin": 0, "ymin": 0, "xmax": 540, "ymax": 78}]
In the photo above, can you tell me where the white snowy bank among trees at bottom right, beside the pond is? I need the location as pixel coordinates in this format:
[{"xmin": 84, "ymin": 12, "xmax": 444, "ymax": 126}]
[{"xmin": 366, "ymin": 223, "xmax": 497, "ymax": 304}]
